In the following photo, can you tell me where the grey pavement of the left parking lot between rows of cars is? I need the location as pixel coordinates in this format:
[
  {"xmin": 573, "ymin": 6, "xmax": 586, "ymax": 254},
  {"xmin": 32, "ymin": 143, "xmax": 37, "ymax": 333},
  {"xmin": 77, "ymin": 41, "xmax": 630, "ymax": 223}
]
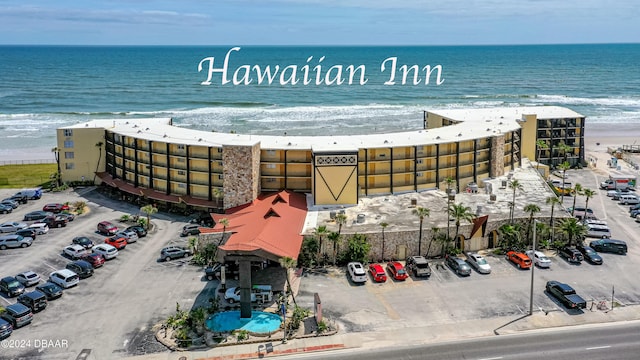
[{"xmin": 0, "ymin": 190, "xmax": 214, "ymax": 359}]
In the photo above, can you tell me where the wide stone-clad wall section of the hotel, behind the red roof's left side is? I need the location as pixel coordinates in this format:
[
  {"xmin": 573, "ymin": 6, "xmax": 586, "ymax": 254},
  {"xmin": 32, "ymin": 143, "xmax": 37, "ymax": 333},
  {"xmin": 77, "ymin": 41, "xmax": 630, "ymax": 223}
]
[{"xmin": 222, "ymin": 143, "xmax": 260, "ymax": 209}]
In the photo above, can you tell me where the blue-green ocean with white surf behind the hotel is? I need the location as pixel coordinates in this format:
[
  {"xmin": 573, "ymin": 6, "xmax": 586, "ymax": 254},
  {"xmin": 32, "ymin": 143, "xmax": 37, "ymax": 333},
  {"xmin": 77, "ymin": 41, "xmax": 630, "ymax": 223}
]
[{"xmin": 0, "ymin": 44, "xmax": 640, "ymax": 160}]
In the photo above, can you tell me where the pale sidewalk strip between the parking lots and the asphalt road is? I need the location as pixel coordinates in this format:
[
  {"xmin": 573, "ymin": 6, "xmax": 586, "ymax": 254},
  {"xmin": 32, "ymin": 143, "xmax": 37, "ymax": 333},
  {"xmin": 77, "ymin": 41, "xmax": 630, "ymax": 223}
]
[{"xmin": 128, "ymin": 306, "xmax": 640, "ymax": 360}]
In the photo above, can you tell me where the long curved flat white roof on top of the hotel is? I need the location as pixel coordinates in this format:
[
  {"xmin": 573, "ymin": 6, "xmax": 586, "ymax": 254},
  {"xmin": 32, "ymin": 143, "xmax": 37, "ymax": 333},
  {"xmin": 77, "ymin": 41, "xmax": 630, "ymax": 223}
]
[{"xmin": 64, "ymin": 106, "xmax": 583, "ymax": 151}]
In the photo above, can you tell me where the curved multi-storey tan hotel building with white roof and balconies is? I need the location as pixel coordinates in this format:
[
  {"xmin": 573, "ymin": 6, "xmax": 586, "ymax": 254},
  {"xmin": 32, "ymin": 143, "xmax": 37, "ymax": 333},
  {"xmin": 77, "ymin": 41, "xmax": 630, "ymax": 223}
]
[{"xmin": 57, "ymin": 106, "xmax": 585, "ymax": 211}]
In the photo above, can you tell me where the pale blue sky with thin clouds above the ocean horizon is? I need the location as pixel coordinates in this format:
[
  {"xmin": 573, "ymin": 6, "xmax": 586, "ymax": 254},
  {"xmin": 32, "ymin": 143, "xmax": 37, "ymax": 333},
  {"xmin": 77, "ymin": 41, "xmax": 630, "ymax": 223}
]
[{"xmin": 0, "ymin": 0, "xmax": 640, "ymax": 45}]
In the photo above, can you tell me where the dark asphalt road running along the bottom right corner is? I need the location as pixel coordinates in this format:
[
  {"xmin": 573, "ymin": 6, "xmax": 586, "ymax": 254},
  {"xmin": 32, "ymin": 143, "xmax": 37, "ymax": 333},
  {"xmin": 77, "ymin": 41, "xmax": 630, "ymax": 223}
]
[{"xmin": 283, "ymin": 322, "xmax": 640, "ymax": 360}]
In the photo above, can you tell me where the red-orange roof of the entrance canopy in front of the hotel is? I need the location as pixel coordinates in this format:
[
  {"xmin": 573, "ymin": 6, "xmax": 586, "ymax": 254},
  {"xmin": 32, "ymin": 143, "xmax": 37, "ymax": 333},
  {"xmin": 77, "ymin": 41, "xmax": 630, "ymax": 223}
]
[{"xmin": 201, "ymin": 190, "xmax": 307, "ymax": 259}]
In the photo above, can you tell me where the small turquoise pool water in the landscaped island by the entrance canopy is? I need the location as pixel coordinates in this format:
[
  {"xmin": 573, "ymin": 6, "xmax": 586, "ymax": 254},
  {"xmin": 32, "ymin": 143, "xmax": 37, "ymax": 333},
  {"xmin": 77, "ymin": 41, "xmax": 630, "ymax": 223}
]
[{"xmin": 206, "ymin": 311, "xmax": 282, "ymax": 333}]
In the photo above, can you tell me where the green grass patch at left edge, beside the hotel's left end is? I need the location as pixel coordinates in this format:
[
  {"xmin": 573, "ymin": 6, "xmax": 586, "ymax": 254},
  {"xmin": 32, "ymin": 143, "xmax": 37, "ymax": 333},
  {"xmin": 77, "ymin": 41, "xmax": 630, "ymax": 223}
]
[{"xmin": 0, "ymin": 164, "xmax": 57, "ymax": 189}]
